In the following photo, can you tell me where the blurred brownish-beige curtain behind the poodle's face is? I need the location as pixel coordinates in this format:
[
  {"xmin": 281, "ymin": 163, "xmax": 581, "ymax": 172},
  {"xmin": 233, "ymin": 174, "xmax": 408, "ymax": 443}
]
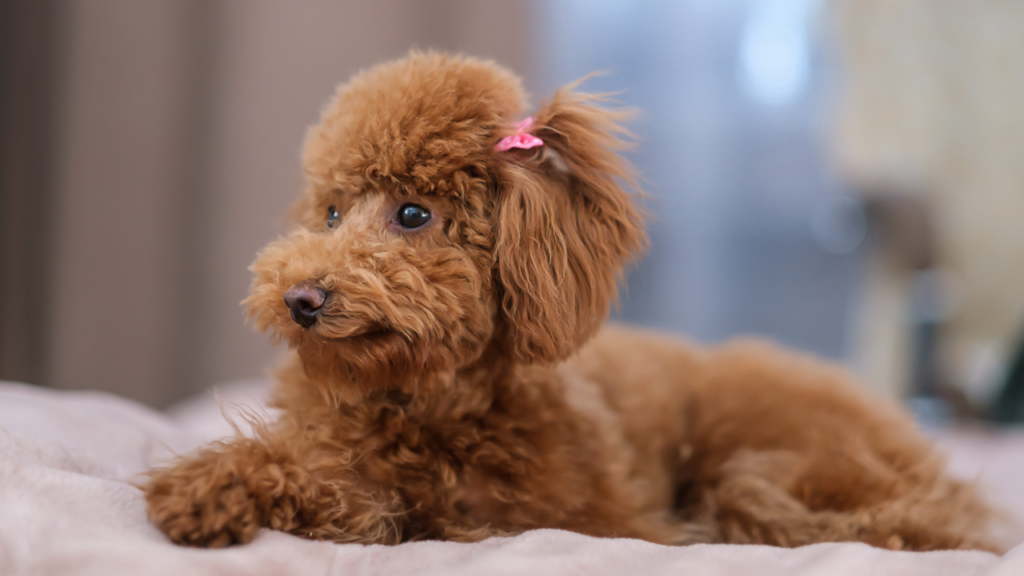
[{"xmin": 40, "ymin": 0, "xmax": 534, "ymax": 406}]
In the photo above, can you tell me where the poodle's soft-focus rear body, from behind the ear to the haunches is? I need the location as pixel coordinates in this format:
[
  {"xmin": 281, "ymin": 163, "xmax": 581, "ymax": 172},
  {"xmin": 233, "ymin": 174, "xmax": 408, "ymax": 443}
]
[{"xmin": 565, "ymin": 326, "xmax": 995, "ymax": 550}]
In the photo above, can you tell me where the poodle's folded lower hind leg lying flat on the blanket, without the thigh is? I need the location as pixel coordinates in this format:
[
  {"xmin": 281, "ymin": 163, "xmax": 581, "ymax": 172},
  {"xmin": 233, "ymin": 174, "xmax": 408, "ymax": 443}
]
[{"xmin": 705, "ymin": 451, "xmax": 995, "ymax": 550}]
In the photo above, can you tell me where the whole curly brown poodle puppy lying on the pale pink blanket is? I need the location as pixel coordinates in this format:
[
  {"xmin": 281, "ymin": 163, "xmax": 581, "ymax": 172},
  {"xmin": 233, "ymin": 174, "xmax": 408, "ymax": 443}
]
[{"xmin": 145, "ymin": 53, "xmax": 990, "ymax": 550}]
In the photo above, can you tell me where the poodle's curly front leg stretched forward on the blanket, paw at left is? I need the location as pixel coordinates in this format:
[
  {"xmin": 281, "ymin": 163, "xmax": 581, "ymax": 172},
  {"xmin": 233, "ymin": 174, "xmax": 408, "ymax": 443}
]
[{"xmin": 143, "ymin": 438, "xmax": 400, "ymax": 547}]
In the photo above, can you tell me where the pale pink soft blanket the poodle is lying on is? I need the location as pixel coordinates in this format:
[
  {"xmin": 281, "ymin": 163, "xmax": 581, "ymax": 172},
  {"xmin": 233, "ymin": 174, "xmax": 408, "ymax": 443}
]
[{"xmin": 0, "ymin": 377, "xmax": 1024, "ymax": 576}]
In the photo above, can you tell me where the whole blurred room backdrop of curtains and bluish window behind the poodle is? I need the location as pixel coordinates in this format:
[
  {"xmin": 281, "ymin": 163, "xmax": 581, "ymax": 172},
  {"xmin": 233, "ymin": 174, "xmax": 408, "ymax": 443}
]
[{"xmin": 0, "ymin": 0, "xmax": 1024, "ymax": 421}]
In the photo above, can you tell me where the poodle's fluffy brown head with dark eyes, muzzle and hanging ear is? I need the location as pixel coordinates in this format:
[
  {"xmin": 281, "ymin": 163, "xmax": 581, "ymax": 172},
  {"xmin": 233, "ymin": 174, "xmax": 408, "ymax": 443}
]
[{"xmin": 245, "ymin": 53, "xmax": 645, "ymax": 387}]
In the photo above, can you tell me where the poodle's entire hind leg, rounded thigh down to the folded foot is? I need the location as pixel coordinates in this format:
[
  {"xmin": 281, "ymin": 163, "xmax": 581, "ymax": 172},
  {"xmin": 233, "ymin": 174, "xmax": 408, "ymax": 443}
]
[{"xmin": 679, "ymin": 342, "xmax": 992, "ymax": 550}]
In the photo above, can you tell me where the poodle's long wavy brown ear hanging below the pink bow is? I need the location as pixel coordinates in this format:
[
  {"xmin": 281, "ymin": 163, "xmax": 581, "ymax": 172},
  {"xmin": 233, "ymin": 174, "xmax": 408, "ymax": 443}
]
[{"xmin": 495, "ymin": 83, "xmax": 647, "ymax": 363}]
